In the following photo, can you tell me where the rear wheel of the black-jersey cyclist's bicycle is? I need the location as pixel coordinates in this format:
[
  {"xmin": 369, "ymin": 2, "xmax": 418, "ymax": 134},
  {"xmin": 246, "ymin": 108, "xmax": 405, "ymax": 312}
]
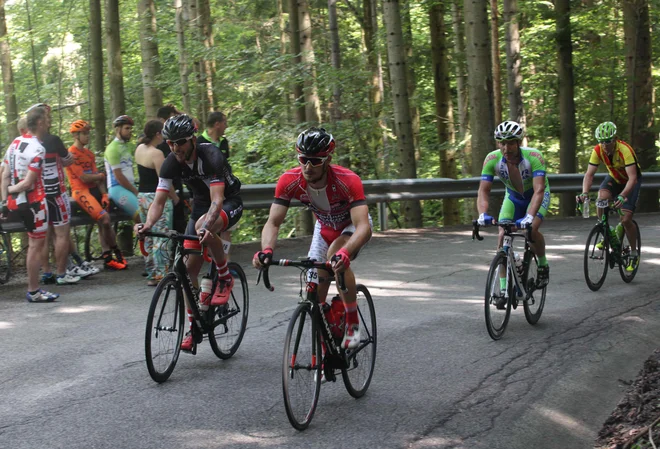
[{"xmin": 209, "ymin": 262, "xmax": 250, "ymax": 359}]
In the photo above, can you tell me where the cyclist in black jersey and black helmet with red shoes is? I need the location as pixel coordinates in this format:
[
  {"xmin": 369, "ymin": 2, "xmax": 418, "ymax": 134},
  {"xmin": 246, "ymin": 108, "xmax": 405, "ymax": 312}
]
[{"xmin": 135, "ymin": 114, "xmax": 243, "ymax": 351}]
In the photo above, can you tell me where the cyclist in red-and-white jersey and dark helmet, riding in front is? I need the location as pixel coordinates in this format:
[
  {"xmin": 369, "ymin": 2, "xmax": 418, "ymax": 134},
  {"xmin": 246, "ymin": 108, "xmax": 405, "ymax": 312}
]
[{"xmin": 252, "ymin": 128, "xmax": 371, "ymax": 349}]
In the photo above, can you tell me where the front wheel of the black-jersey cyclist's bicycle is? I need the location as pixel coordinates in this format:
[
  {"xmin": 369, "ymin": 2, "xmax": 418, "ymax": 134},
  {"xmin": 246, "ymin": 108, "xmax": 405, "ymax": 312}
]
[{"xmin": 144, "ymin": 273, "xmax": 184, "ymax": 383}]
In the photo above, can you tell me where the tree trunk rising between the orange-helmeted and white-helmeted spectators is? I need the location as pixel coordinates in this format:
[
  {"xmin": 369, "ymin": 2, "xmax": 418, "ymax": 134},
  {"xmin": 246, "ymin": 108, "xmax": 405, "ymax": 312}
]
[{"xmin": 89, "ymin": 0, "xmax": 105, "ymax": 154}]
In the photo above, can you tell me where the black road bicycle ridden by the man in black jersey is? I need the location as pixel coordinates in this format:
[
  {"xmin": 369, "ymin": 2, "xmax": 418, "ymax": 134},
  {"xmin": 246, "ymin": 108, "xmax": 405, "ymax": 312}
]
[{"xmin": 140, "ymin": 231, "xmax": 249, "ymax": 383}]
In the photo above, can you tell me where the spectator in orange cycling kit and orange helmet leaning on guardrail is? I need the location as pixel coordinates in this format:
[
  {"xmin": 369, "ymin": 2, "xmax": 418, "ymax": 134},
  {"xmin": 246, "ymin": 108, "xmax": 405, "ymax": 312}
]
[{"xmin": 66, "ymin": 120, "xmax": 126, "ymax": 270}]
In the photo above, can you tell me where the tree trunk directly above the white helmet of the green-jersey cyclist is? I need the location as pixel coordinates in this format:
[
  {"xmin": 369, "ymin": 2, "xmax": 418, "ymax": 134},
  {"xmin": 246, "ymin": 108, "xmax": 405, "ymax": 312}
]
[{"xmin": 504, "ymin": 0, "xmax": 526, "ymax": 127}]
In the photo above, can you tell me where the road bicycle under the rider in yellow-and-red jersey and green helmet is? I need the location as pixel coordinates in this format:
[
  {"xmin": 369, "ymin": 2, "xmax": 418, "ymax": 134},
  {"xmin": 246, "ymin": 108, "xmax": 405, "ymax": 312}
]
[{"xmin": 578, "ymin": 199, "xmax": 642, "ymax": 291}]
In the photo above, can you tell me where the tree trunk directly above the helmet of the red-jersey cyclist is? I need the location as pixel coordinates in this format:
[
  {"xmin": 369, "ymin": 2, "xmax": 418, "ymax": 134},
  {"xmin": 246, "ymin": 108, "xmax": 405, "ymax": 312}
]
[{"xmin": 298, "ymin": 0, "xmax": 321, "ymax": 125}]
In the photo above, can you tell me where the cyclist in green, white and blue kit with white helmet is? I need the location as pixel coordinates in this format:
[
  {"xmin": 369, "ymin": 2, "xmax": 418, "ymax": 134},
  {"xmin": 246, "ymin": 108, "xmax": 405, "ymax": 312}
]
[{"xmin": 477, "ymin": 120, "xmax": 550, "ymax": 290}]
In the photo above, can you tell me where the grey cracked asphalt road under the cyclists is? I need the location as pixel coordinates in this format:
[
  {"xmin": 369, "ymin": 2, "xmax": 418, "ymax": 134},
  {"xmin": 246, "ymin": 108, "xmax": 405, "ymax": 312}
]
[{"xmin": 0, "ymin": 215, "xmax": 660, "ymax": 449}]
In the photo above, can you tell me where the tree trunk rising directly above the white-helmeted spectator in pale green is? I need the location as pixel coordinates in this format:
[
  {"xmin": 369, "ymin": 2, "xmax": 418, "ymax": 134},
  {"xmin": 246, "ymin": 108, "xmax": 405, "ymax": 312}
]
[{"xmin": 105, "ymin": 0, "xmax": 126, "ymax": 118}]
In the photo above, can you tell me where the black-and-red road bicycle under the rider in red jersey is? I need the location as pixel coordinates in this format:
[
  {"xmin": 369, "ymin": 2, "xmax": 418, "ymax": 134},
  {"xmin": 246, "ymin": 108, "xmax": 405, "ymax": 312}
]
[{"xmin": 257, "ymin": 259, "xmax": 377, "ymax": 430}]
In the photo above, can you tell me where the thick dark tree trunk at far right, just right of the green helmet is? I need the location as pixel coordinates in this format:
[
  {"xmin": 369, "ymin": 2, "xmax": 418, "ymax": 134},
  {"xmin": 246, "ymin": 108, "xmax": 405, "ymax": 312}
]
[{"xmin": 623, "ymin": 0, "xmax": 658, "ymax": 212}]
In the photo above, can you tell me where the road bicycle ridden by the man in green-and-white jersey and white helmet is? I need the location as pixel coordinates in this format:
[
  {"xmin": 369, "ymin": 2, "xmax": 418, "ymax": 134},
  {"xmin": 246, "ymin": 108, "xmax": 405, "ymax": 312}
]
[{"xmin": 472, "ymin": 220, "xmax": 548, "ymax": 340}]
